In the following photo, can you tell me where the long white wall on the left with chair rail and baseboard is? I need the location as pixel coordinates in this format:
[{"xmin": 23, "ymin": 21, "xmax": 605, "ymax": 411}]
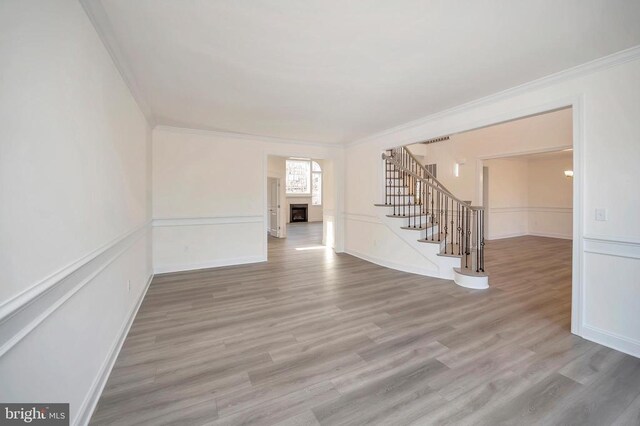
[{"xmin": 0, "ymin": 0, "xmax": 152, "ymax": 423}]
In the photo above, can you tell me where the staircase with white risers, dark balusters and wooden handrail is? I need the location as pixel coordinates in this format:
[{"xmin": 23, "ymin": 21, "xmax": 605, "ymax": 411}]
[{"xmin": 376, "ymin": 147, "xmax": 489, "ymax": 289}]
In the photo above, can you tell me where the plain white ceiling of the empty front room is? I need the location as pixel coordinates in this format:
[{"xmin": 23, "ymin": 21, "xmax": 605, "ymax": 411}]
[{"xmin": 91, "ymin": 0, "xmax": 640, "ymax": 143}]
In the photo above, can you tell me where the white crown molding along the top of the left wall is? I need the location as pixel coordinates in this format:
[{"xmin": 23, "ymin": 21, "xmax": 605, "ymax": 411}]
[{"xmin": 80, "ymin": 0, "xmax": 156, "ymax": 128}]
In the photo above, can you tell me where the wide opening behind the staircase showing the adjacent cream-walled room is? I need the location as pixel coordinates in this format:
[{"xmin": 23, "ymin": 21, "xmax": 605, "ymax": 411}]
[{"xmin": 408, "ymin": 107, "xmax": 574, "ymax": 329}]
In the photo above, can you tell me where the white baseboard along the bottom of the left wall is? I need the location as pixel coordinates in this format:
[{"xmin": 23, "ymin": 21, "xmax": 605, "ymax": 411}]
[{"xmin": 74, "ymin": 274, "xmax": 154, "ymax": 425}]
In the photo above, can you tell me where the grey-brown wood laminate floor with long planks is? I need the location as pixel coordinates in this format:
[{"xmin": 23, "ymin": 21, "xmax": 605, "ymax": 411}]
[{"xmin": 91, "ymin": 224, "xmax": 640, "ymax": 426}]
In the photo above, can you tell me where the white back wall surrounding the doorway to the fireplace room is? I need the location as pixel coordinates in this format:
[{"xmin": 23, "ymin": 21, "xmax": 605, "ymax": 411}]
[{"xmin": 153, "ymin": 127, "xmax": 343, "ymax": 272}]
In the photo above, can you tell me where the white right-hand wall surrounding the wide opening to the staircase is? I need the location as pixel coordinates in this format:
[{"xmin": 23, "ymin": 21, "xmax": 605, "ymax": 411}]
[{"xmin": 345, "ymin": 54, "xmax": 640, "ymax": 356}]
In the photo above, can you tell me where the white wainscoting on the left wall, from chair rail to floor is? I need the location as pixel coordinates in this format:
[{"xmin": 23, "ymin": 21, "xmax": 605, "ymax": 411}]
[{"xmin": 0, "ymin": 224, "xmax": 153, "ymax": 424}]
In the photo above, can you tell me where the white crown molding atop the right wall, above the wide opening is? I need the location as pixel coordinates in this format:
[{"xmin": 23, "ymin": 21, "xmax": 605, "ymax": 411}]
[{"xmin": 345, "ymin": 45, "xmax": 640, "ymax": 147}]
